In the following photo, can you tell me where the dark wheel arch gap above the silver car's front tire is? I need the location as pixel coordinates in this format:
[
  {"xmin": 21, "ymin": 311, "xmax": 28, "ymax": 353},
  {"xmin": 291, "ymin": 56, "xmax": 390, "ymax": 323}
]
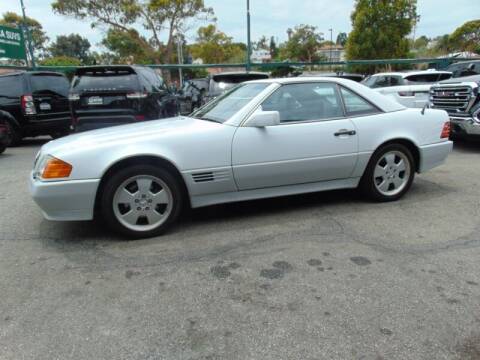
[{"xmin": 94, "ymin": 155, "xmax": 191, "ymax": 216}]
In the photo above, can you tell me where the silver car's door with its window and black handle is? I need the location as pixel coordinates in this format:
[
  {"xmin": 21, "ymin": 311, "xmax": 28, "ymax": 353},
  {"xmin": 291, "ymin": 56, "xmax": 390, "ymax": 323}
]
[{"xmin": 232, "ymin": 82, "xmax": 358, "ymax": 190}]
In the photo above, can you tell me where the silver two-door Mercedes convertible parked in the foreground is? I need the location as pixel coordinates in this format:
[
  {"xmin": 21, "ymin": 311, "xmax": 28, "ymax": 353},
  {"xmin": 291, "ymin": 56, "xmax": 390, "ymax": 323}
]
[{"xmin": 30, "ymin": 77, "xmax": 452, "ymax": 238}]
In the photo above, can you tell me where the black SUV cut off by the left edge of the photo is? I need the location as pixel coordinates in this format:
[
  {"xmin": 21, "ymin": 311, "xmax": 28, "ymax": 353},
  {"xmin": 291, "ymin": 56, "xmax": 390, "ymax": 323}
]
[{"xmin": 0, "ymin": 71, "xmax": 71, "ymax": 145}]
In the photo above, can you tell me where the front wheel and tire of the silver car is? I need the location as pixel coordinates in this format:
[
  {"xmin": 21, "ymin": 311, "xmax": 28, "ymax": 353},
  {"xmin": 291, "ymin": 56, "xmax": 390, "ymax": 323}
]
[{"xmin": 100, "ymin": 165, "xmax": 184, "ymax": 239}]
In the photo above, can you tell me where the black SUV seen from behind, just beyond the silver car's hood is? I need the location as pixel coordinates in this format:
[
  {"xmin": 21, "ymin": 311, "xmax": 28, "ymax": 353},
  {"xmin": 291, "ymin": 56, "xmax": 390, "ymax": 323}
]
[{"xmin": 69, "ymin": 65, "xmax": 177, "ymax": 132}]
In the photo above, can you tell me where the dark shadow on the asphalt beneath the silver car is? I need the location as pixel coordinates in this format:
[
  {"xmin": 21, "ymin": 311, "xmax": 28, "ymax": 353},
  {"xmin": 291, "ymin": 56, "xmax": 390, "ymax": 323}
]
[{"xmin": 40, "ymin": 190, "xmax": 365, "ymax": 250}]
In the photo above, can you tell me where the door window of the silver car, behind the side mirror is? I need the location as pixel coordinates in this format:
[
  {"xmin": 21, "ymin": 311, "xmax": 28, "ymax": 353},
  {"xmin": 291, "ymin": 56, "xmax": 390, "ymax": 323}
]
[{"xmin": 262, "ymin": 83, "xmax": 344, "ymax": 123}]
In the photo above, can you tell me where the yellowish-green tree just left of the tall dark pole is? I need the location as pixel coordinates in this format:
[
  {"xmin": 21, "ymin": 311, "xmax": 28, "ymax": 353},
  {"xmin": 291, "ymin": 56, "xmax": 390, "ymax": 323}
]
[{"xmin": 189, "ymin": 24, "xmax": 246, "ymax": 64}]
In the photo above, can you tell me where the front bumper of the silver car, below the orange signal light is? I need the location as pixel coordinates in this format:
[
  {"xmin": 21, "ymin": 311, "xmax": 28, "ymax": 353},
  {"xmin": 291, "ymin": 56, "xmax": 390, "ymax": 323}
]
[{"xmin": 30, "ymin": 173, "xmax": 100, "ymax": 221}]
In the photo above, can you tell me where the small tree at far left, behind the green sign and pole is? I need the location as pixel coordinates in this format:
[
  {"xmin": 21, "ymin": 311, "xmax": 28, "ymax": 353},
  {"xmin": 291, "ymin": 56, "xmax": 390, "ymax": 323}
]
[{"xmin": 0, "ymin": 12, "xmax": 48, "ymax": 59}]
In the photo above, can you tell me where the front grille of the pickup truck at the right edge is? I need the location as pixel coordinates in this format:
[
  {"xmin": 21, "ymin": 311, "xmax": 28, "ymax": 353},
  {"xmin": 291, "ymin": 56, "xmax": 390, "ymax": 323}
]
[{"xmin": 430, "ymin": 85, "xmax": 473, "ymax": 114}]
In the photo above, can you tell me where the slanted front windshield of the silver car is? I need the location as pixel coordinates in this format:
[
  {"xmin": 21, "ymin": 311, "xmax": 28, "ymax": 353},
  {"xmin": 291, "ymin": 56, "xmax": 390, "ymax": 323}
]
[{"xmin": 192, "ymin": 83, "xmax": 270, "ymax": 123}]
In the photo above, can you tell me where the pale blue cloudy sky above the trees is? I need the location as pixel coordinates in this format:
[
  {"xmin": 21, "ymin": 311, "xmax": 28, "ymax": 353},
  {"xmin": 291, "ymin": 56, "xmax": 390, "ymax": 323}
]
[{"xmin": 0, "ymin": 0, "xmax": 480, "ymax": 46}]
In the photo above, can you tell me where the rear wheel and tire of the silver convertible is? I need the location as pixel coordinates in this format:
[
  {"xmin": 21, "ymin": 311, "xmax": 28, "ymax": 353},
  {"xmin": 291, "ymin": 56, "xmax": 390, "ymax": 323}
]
[{"xmin": 360, "ymin": 144, "xmax": 416, "ymax": 202}]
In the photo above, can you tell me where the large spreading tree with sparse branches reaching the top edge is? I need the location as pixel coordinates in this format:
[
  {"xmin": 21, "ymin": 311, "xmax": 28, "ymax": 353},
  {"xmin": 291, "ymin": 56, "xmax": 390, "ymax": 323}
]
[{"xmin": 52, "ymin": 0, "xmax": 213, "ymax": 62}]
